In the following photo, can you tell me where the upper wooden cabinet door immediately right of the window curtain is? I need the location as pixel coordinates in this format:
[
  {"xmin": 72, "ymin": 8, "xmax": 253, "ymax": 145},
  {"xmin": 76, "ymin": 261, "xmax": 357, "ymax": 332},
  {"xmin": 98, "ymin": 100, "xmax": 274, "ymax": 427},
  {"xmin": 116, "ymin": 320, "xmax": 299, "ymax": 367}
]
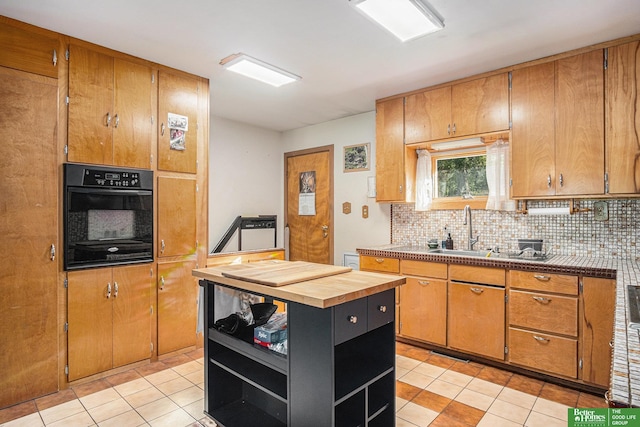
[{"xmin": 511, "ymin": 62, "xmax": 556, "ymax": 197}]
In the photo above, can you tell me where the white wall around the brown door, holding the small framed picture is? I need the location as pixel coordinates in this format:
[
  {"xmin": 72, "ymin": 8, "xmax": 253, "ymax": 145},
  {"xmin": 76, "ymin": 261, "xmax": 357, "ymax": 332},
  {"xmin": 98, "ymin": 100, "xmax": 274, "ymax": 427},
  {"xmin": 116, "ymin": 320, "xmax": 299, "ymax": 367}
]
[{"xmin": 281, "ymin": 111, "xmax": 391, "ymax": 265}]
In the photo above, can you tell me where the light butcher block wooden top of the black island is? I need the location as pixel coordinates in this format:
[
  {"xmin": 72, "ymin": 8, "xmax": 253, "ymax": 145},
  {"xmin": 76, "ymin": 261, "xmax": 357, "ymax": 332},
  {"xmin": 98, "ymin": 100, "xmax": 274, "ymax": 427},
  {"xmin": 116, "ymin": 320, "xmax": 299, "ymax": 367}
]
[{"xmin": 193, "ymin": 260, "xmax": 405, "ymax": 308}]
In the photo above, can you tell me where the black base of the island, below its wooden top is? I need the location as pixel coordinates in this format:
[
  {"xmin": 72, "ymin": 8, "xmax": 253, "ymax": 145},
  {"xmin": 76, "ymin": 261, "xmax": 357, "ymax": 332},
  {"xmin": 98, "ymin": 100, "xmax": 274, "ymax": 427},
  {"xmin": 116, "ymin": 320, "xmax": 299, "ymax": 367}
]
[{"xmin": 202, "ymin": 281, "xmax": 395, "ymax": 427}]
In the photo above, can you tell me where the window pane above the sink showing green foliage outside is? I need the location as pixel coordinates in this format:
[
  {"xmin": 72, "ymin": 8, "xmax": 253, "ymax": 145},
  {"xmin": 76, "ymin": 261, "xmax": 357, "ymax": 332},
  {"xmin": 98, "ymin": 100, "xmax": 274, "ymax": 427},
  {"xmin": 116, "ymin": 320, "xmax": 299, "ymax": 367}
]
[{"xmin": 436, "ymin": 155, "xmax": 489, "ymax": 198}]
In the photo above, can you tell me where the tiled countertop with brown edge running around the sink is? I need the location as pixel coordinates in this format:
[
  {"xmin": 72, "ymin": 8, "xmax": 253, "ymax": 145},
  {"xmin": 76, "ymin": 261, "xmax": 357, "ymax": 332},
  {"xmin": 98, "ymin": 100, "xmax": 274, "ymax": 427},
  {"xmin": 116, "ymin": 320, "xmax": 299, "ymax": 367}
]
[{"xmin": 357, "ymin": 245, "xmax": 640, "ymax": 406}]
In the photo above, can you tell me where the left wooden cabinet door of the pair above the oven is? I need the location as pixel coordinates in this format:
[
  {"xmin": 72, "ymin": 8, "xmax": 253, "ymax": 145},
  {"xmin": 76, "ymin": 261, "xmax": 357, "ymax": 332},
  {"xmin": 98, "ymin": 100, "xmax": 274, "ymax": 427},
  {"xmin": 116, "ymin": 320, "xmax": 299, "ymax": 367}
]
[{"xmin": 67, "ymin": 45, "xmax": 115, "ymax": 165}]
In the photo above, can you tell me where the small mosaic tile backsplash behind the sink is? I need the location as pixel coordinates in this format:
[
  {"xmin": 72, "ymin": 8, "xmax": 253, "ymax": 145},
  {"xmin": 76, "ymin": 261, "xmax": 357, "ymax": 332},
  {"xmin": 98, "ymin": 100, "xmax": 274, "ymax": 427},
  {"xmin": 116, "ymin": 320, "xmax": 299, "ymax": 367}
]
[{"xmin": 391, "ymin": 199, "xmax": 640, "ymax": 261}]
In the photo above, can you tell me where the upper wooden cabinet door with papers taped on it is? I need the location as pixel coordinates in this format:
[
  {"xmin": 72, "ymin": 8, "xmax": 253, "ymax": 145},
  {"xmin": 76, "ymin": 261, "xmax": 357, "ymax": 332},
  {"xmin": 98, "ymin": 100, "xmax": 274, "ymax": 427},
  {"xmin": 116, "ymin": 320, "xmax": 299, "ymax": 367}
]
[{"xmin": 158, "ymin": 70, "xmax": 198, "ymax": 173}]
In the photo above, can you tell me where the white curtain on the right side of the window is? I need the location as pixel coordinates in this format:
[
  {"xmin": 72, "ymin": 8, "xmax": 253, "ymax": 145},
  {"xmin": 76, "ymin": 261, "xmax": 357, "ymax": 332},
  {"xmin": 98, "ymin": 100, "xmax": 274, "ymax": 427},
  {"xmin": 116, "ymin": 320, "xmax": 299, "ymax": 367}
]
[{"xmin": 486, "ymin": 139, "xmax": 515, "ymax": 211}]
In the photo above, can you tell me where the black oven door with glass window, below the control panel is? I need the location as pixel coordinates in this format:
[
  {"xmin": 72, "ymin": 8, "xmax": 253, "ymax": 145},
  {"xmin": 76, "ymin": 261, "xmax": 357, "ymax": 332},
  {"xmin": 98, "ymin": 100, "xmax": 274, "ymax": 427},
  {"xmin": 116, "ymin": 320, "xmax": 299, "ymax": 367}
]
[{"xmin": 64, "ymin": 187, "xmax": 153, "ymax": 270}]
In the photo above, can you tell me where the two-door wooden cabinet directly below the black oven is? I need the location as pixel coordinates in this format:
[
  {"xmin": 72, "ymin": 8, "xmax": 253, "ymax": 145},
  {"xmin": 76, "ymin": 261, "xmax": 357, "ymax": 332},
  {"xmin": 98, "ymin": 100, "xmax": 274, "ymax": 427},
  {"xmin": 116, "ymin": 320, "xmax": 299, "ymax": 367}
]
[{"xmin": 67, "ymin": 265, "xmax": 153, "ymax": 381}]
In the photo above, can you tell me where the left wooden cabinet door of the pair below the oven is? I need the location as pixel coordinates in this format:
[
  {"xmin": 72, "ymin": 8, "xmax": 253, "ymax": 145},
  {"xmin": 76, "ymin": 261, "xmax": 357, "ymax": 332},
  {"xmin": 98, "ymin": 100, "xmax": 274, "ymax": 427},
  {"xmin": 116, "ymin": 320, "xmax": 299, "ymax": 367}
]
[{"xmin": 67, "ymin": 268, "xmax": 115, "ymax": 381}]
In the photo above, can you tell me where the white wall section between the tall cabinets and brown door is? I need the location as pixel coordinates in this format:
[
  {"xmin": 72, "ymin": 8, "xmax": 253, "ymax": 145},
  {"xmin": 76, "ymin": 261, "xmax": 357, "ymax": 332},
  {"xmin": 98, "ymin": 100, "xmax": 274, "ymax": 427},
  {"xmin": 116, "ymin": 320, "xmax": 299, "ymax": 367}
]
[{"xmin": 209, "ymin": 116, "xmax": 284, "ymax": 252}]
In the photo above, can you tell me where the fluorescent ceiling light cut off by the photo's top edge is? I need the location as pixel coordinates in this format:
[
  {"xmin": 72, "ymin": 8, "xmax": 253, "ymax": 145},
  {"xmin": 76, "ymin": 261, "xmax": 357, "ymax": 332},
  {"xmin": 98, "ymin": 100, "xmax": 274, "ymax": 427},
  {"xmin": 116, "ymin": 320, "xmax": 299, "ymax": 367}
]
[{"xmin": 349, "ymin": 0, "xmax": 444, "ymax": 42}]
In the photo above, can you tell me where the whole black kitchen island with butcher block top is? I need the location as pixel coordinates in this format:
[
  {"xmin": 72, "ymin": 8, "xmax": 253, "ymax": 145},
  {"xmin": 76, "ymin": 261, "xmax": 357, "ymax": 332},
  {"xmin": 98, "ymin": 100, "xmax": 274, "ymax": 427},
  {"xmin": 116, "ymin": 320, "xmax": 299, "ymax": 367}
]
[{"xmin": 193, "ymin": 261, "xmax": 405, "ymax": 427}]
